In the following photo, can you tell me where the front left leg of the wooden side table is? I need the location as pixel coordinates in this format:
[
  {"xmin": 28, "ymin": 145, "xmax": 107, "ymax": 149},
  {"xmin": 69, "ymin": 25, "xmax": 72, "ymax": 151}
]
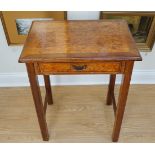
[{"xmin": 26, "ymin": 63, "xmax": 49, "ymax": 141}]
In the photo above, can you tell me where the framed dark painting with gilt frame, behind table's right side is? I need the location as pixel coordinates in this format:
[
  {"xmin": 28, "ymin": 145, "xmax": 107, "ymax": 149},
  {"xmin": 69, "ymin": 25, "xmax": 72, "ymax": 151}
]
[{"xmin": 100, "ymin": 11, "xmax": 155, "ymax": 51}]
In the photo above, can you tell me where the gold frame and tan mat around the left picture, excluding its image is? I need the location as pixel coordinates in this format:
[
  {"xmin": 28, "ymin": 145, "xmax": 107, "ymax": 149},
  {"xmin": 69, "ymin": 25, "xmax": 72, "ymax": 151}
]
[{"xmin": 1, "ymin": 11, "xmax": 67, "ymax": 45}]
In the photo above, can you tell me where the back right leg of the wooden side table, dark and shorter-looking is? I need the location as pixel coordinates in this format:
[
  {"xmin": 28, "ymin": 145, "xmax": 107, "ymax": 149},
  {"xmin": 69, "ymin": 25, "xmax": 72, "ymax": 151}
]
[{"xmin": 106, "ymin": 74, "xmax": 116, "ymax": 105}]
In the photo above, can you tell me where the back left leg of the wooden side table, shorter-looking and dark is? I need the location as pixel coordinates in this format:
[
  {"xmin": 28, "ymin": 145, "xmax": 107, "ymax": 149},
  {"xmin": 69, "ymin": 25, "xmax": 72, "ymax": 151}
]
[{"xmin": 44, "ymin": 75, "xmax": 53, "ymax": 104}]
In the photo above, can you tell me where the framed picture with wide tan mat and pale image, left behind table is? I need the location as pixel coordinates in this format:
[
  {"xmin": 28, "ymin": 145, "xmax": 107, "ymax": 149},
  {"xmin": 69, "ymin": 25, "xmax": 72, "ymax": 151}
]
[{"xmin": 1, "ymin": 11, "xmax": 67, "ymax": 45}]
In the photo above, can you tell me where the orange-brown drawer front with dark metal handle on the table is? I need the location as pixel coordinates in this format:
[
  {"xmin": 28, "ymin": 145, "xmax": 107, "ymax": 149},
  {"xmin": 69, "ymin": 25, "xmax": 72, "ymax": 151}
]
[{"xmin": 37, "ymin": 62, "xmax": 123, "ymax": 74}]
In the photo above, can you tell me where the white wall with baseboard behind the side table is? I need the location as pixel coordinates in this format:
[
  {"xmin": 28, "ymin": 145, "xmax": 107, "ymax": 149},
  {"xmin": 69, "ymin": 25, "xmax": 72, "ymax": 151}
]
[{"xmin": 0, "ymin": 11, "xmax": 155, "ymax": 86}]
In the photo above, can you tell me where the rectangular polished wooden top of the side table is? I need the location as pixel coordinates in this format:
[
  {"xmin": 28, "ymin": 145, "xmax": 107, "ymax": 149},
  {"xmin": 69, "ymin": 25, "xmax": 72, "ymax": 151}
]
[{"xmin": 19, "ymin": 20, "xmax": 141, "ymax": 63}]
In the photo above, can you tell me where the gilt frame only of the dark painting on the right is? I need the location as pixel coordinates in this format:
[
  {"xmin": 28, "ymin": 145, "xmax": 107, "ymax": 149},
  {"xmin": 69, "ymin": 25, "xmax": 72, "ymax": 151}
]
[{"xmin": 100, "ymin": 11, "xmax": 155, "ymax": 51}]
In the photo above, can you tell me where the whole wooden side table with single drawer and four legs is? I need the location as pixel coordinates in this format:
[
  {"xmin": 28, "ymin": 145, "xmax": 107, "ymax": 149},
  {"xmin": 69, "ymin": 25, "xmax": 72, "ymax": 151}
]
[{"xmin": 19, "ymin": 20, "xmax": 142, "ymax": 142}]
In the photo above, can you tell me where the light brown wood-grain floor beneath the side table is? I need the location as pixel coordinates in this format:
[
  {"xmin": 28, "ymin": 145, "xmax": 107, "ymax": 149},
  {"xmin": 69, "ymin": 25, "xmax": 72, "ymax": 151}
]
[{"xmin": 0, "ymin": 85, "xmax": 155, "ymax": 143}]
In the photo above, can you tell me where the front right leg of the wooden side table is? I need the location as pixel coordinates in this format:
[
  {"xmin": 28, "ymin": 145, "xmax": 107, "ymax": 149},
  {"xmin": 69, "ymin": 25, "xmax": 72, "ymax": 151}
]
[{"xmin": 112, "ymin": 61, "xmax": 134, "ymax": 142}]
